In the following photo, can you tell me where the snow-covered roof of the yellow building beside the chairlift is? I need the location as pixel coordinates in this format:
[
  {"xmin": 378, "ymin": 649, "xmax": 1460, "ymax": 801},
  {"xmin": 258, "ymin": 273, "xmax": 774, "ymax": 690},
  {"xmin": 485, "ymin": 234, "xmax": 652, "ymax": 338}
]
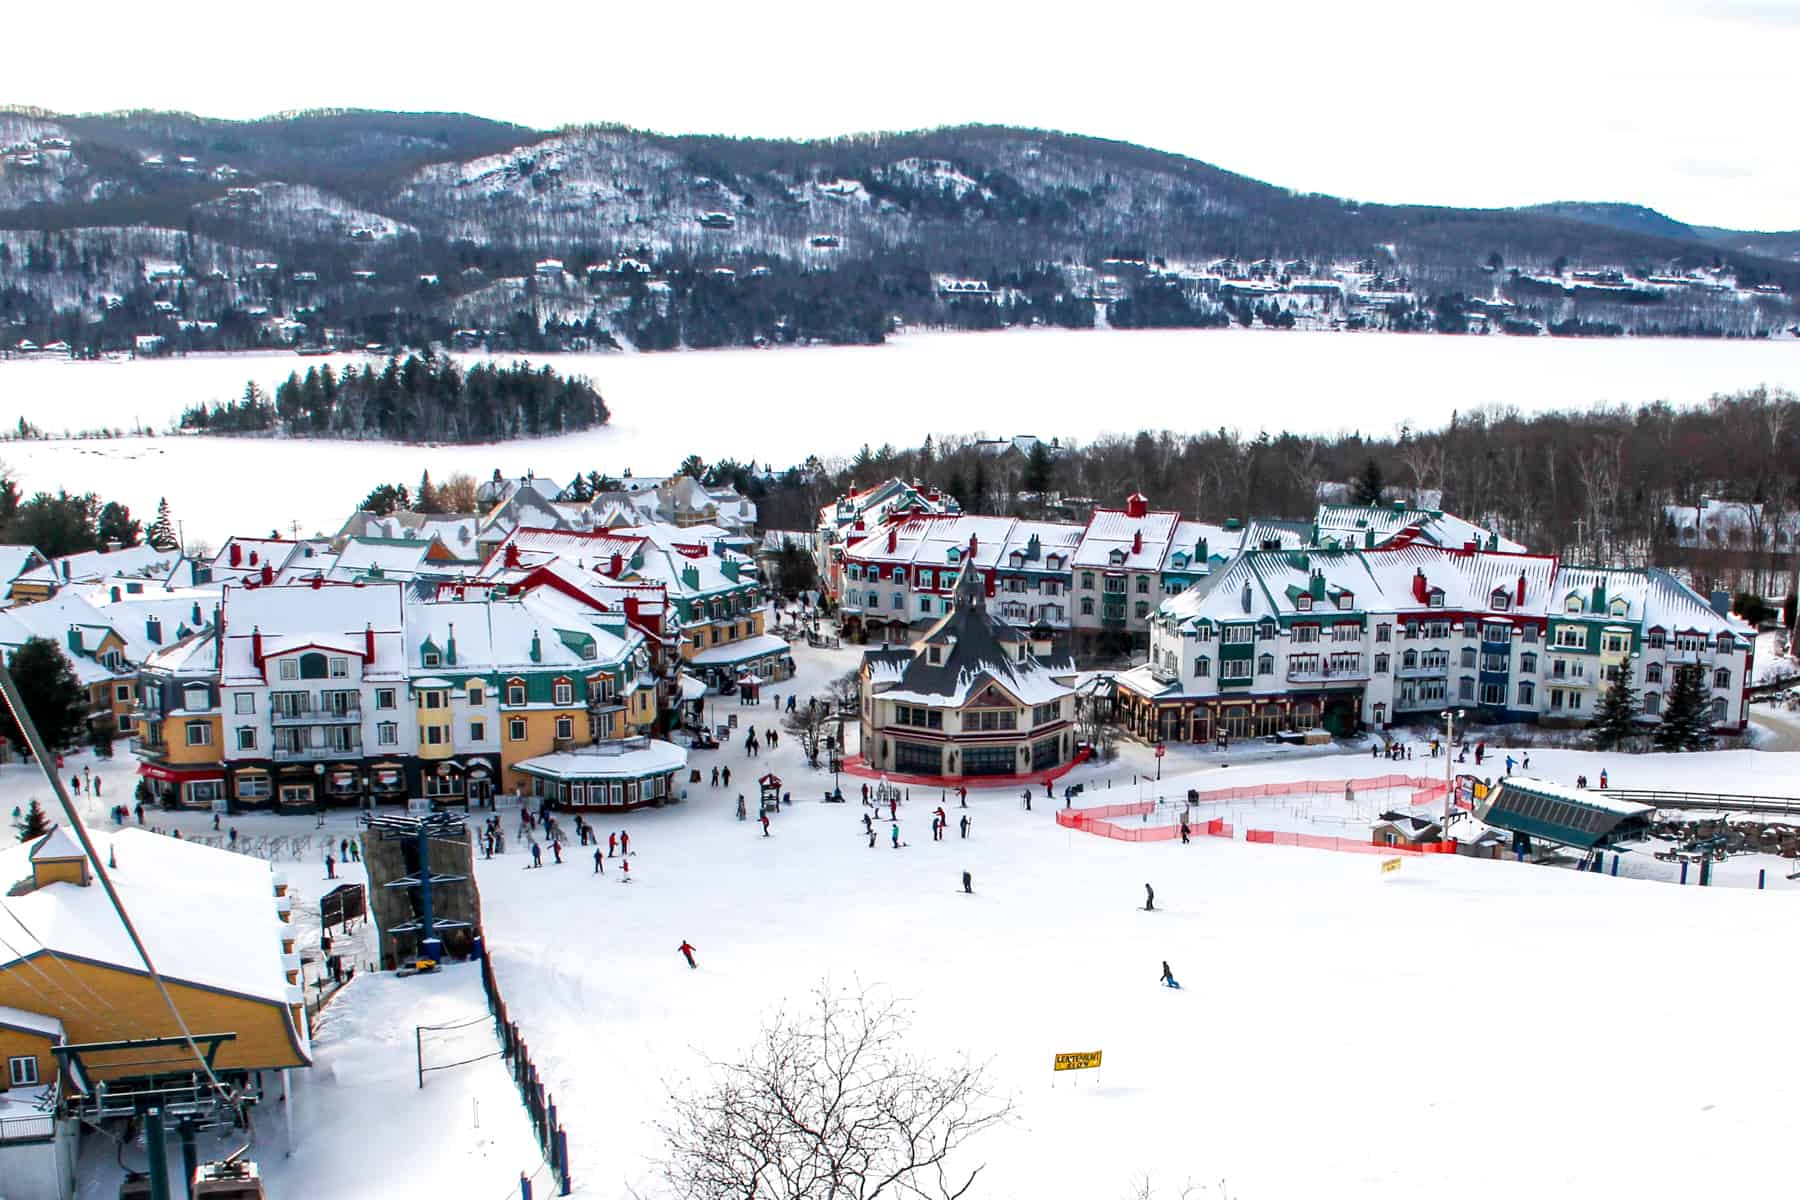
[{"xmin": 0, "ymin": 829, "xmax": 298, "ymax": 1006}]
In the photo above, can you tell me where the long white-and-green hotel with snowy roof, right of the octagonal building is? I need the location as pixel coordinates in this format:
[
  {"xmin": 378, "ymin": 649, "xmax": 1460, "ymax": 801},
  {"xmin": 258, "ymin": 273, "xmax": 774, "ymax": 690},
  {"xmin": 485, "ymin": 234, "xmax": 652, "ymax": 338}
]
[{"xmin": 1116, "ymin": 542, "xmax": 1755, "ymax": 741}]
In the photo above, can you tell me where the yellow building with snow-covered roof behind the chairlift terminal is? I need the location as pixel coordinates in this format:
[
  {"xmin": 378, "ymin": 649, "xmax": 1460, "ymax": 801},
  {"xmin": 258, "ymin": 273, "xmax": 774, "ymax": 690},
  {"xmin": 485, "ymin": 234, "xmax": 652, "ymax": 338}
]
[{"xmin": 0, "ymin": 828, "xmax": 311, "ymax": 1198}]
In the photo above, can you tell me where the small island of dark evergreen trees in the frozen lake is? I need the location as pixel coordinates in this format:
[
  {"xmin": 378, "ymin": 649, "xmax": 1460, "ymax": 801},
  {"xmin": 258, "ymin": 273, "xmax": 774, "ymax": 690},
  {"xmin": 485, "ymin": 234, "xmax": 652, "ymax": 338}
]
[{"xmin": 180, "ymin": 353, "xmax": 610, "ymax": 443}]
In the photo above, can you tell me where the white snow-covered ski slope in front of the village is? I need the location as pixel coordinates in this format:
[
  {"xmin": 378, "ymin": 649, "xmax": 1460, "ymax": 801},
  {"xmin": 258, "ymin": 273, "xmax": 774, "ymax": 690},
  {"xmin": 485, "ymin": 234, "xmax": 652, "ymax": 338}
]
[{"xmin": 0, "ymin": 633, "xmax": 1800, "ymax": 1200}]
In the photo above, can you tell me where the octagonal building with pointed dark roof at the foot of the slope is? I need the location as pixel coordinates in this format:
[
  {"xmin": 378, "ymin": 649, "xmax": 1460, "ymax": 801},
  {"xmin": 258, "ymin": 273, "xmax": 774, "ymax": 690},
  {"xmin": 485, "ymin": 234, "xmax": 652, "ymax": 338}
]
[{"xmin": 860, "ymin": 565, "xmax": 1075, "ymax": 779}]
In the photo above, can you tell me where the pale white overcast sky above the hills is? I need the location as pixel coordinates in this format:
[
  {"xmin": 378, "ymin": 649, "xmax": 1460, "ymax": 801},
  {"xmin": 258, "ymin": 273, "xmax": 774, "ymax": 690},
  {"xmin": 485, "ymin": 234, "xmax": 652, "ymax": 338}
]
[{"xmin": 14, "ymin": 0, "xmax": 1800, "ymax": 230}]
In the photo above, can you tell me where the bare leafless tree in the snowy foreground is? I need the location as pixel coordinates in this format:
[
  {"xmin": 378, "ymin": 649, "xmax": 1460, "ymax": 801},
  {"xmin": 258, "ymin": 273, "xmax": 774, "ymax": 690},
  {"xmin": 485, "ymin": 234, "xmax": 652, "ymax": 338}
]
[{"xmin": 661, "ymin": 984, "xmax": 1012, "ymax": 1200}]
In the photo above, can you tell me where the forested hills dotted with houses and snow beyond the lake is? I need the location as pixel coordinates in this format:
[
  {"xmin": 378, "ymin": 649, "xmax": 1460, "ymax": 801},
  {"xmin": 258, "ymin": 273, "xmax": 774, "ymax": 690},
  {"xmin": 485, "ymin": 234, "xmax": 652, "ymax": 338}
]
[{"xmin": 0, "ymin": 110, "xmax": 1800, "ymax": 354}]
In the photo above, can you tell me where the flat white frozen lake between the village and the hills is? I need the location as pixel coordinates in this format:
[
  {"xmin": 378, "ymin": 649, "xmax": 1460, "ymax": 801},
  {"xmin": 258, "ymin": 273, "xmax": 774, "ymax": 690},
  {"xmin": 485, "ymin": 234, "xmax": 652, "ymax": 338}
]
[{"xmin": 0, "ymin": 329, "xmax": 1800, "ymax": 543}]
